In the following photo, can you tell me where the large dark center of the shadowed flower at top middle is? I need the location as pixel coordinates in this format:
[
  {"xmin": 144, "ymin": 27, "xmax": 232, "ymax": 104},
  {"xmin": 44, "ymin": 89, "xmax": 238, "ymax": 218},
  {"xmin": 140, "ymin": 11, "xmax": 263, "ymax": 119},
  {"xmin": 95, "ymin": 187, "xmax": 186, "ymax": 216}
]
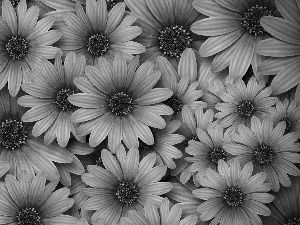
[{"xmin": 158, "ymin": 25, "xmax": 192, "ymax": 58}]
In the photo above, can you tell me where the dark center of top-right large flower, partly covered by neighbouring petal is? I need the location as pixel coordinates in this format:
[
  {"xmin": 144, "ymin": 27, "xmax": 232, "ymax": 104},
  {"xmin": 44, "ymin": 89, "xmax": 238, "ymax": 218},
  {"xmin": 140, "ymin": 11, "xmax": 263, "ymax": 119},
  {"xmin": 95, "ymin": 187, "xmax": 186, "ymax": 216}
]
[{"xmin": 241, "ymin": 5, "xmax": 272, "ymax": 36}]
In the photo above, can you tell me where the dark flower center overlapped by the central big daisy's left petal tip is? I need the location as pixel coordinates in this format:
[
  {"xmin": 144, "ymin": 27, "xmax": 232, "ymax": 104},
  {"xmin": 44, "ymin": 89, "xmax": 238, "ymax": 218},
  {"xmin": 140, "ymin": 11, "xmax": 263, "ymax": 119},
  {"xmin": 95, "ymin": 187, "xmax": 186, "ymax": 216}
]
[{"xmin": 54, "ymin": 88, "xmax": 75, "ymax": 111}]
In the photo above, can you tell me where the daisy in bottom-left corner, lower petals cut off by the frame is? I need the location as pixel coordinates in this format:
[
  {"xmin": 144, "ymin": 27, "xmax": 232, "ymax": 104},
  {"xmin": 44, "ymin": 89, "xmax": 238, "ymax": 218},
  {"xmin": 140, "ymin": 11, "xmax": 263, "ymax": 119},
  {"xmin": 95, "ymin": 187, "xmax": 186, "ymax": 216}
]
[{"xmin": 0, "ymin": 171, "xmax": 78, "ymax": 225}]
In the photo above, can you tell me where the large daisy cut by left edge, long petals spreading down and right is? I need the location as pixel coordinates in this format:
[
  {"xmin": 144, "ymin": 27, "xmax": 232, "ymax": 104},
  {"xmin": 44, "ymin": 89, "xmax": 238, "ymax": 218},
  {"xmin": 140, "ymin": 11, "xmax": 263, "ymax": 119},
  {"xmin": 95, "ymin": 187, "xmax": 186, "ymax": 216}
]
[{"xmin": 0, "ymin": 87, "xmax": 74, "ymax": 180}]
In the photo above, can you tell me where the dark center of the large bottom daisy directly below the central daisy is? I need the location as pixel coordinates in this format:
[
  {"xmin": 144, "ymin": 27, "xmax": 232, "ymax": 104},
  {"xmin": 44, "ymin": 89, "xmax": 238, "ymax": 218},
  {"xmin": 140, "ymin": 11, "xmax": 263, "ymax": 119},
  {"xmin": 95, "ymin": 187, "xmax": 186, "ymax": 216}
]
[{"xmin": 116, "ymin": 181, "xmax": 139, "ymax": 205}]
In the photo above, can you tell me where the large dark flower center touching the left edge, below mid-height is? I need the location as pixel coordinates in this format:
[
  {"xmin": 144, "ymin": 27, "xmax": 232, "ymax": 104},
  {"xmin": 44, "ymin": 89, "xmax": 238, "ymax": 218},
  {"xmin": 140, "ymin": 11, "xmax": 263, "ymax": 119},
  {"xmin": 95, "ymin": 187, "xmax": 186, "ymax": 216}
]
[{"xmin": 0, "ymin": 119, "xmax": 27, "ymax": 150}]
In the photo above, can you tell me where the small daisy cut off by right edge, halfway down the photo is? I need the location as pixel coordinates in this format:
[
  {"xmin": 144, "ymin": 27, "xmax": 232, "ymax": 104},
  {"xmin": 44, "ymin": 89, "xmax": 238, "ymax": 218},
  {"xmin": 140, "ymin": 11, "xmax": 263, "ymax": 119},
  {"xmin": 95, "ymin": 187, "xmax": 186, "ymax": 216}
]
[{"xmin": 270, "ymin": 99, "xmax": 300, "ymax": 134}]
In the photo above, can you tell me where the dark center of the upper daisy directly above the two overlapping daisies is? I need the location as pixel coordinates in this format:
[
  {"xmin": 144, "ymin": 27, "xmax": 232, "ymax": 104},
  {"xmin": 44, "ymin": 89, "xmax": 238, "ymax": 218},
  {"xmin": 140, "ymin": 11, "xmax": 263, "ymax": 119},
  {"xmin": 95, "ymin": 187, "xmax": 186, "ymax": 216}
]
[{"xmin": 87, "ymin": 34, "xmax": 109, "ymax": 56}]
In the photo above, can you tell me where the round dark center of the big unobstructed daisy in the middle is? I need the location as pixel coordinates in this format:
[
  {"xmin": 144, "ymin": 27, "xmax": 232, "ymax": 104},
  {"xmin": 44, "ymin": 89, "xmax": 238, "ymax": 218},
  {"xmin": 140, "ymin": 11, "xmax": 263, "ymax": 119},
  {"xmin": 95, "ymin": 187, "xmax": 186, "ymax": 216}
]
[{"xmin": 108, "ymin": 92, "xmax": 133, "ymax": 116}]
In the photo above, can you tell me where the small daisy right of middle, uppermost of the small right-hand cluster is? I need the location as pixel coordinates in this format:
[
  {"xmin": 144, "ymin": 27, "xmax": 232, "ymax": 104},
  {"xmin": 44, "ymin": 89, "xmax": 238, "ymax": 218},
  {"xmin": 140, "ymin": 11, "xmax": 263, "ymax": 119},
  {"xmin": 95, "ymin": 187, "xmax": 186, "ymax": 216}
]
[{"xmin": 215, "ymin": 77, "xmax": 278, "ymax": 127}]
